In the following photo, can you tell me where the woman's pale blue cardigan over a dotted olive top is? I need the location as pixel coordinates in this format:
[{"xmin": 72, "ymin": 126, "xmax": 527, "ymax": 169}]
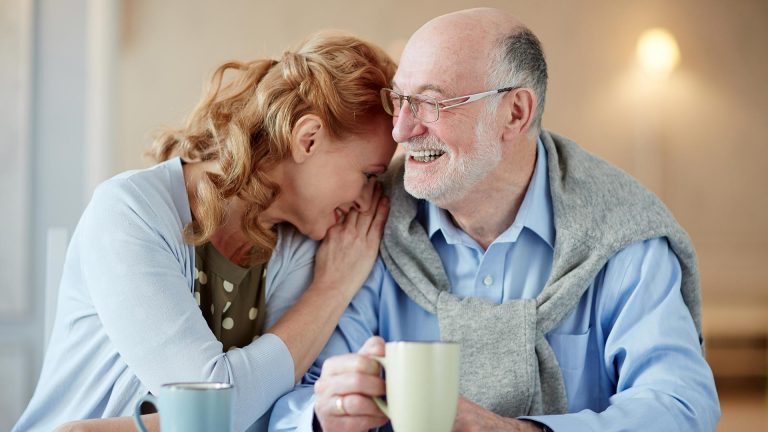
[{"xmin": 14, "ymin": 158, "xmax": 317, "ymax": 431}]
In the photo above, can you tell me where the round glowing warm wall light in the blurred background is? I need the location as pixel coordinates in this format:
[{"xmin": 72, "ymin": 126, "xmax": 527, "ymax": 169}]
[{"xmin": 637, "ymin": 28, "xmax": 680, "ymax": 78}]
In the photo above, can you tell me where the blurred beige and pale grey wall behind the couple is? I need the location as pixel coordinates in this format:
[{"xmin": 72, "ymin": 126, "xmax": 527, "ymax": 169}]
[{"xmin": 0, "ymin": 0, "xmax": 768, "ymax": 430}]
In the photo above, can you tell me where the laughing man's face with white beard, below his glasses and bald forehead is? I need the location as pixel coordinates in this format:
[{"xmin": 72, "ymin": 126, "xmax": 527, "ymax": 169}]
[{"xmin": 392, "ymin": 29, "xmax": 501, "ymax": 207}]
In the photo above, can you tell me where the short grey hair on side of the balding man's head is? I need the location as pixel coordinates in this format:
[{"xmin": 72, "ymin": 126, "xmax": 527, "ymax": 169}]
[{"xmin": 488, "ymin": 27, "xmax": 547, "ymax": 134}]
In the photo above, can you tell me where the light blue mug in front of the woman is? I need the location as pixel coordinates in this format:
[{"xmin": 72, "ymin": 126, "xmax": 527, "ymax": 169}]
[{"xmin": 133, "ymin": 382, "xmax": 232, "ymax": 432}]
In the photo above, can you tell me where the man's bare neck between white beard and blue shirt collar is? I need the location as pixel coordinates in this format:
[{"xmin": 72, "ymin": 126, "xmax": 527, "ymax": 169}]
[{"xmin": 440, "ymin": 142, "xmax": 537, "ymax": 250}]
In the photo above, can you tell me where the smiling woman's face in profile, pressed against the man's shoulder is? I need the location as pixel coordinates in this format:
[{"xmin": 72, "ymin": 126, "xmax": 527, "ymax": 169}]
[{"xmin": 274, "ymin": 116, "xmax": 396, "ymax": 240}]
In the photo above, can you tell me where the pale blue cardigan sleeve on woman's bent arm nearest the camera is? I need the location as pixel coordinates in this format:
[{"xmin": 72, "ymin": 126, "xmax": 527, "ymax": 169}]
[{"xmin": 77, "ymin": 179, "xmax": 293, "ymax": 430}]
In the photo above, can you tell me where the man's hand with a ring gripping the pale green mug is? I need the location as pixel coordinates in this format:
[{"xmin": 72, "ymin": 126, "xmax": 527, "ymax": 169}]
[{"xmin": 315, "ymin": 337, "xmax": 388, "ymax": 432}]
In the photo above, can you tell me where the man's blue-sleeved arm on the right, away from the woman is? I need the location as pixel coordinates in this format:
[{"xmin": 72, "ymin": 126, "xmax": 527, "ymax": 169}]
[{"xmin": 464, "ymin": 239, "xmax": 720, "ymax": 432}]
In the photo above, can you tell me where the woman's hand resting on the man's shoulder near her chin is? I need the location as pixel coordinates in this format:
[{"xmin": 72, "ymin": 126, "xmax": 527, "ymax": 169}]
[{"xmin": 314, "ymin": 183, "xmax": 389, "ymax": 299}]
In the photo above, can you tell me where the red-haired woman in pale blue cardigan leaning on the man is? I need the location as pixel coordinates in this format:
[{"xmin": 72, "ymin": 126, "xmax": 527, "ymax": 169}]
[{"xmin": 14, "ymin": 34, "xmax": 395, "ymax": 431}]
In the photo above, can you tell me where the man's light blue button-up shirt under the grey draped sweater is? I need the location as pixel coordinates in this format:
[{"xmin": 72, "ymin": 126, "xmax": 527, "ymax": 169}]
[{"xmin": 270, "ymin": 141, "xmax": 720, "ymax": 432}]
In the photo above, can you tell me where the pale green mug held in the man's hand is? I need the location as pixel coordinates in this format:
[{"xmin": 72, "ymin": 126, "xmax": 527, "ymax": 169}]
[{"xmin": 372, "ymin": 342, "xmax": 459, "ymax": 432}]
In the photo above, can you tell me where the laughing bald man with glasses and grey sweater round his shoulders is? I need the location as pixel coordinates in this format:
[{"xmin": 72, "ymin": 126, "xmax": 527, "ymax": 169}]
[{"xmin": 270, "ymin": 9, "xmax": 720, "ymax": 432}]
